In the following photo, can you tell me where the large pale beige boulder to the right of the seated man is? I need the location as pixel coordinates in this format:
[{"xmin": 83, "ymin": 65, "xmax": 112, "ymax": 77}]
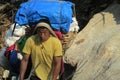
[{"xmin": 64, "ymin": 4, "xmax": 120, "ymax": 80}]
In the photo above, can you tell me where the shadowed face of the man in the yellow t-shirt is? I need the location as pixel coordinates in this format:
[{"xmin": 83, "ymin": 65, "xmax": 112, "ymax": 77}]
[{"xmin": 37, "ymin": 28, "xmax": 50, "ymax": 41}]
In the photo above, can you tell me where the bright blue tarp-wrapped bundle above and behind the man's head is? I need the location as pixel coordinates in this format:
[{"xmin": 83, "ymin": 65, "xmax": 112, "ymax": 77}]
[{"xmin": 15, "ymin": 0, "xmax": 73, "ymax": 33}]
